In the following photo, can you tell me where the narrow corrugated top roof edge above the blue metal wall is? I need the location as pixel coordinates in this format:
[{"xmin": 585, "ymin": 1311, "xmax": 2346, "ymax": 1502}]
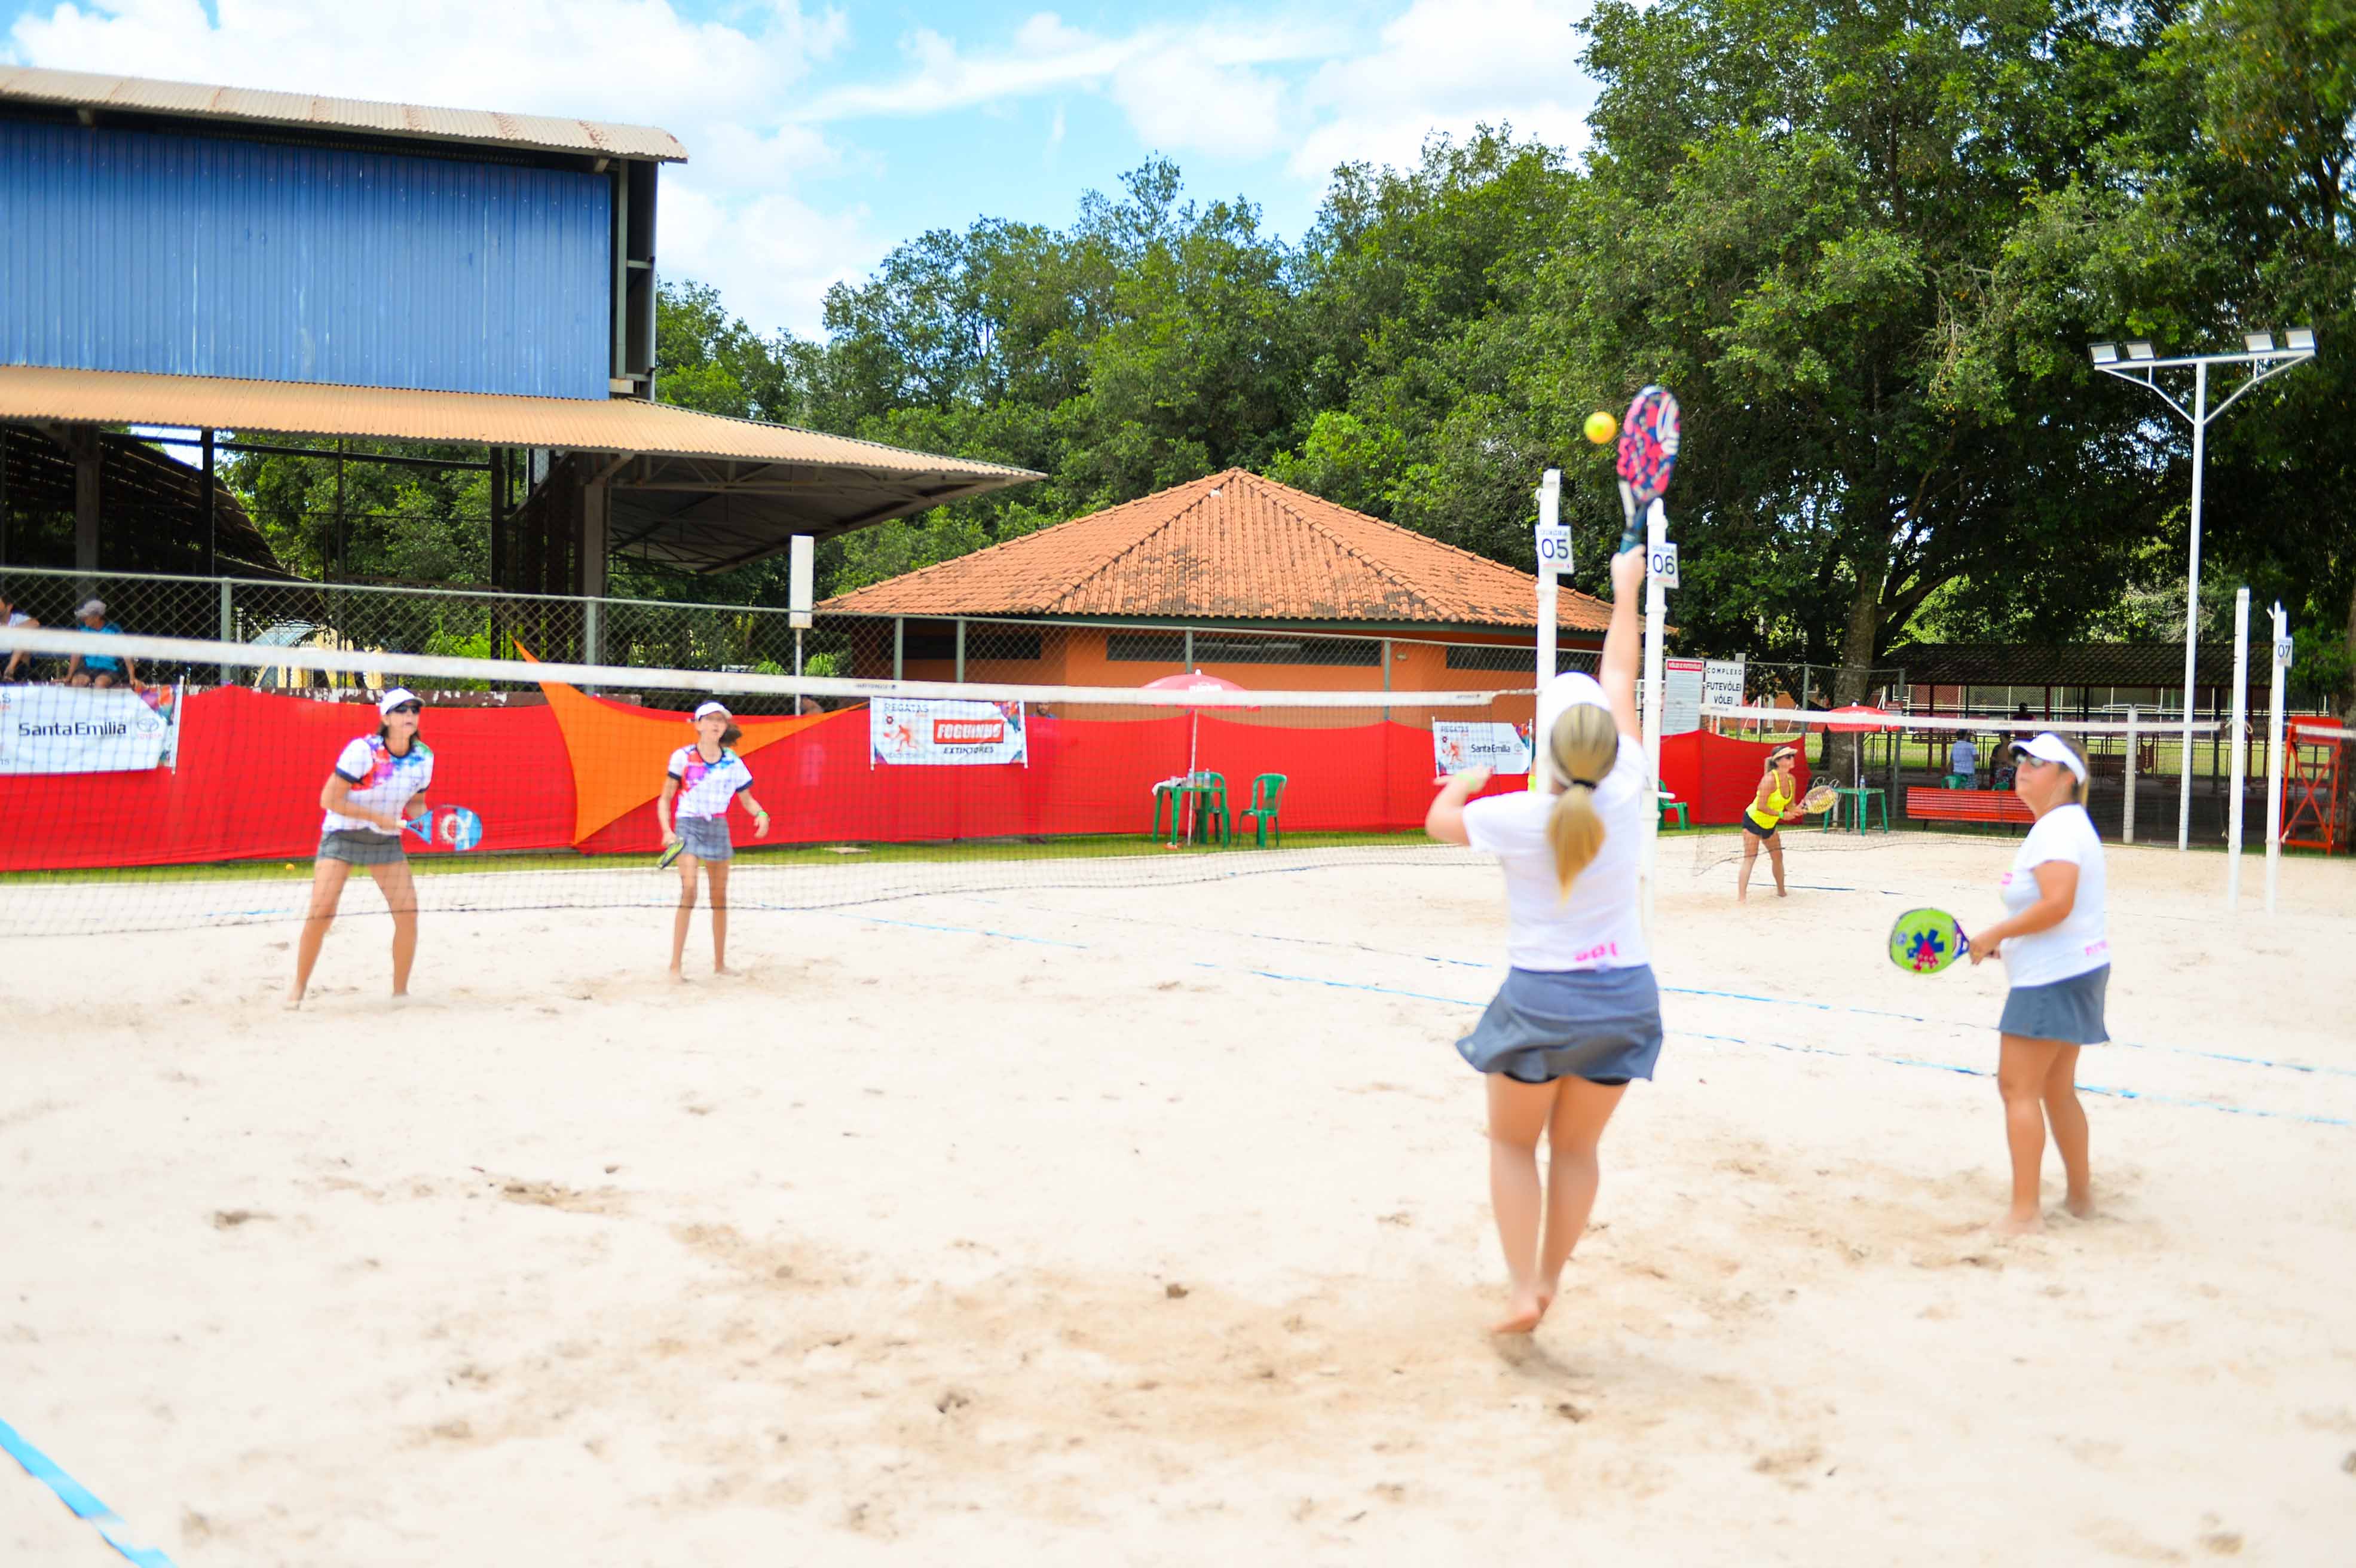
[{"xmin": 0, "ymin": 66, "xmax": 688, "ymax": 163}]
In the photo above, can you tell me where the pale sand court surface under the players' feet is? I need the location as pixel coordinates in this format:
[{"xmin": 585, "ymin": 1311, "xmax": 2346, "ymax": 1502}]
[{"xmin": 0, "ymin": 836, "xmax": 2356, "ymax": 1566}]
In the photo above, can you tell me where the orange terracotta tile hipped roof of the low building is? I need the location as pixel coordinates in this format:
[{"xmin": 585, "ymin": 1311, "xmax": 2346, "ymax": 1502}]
[{"xmin": 822, "ymin": 468, "xmax": 1609, "ymax": 631}]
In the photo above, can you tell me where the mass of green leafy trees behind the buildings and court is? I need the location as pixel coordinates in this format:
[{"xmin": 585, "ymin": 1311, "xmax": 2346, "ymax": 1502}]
[{"xmin": 225, "ymin": 0, "xmax": 2356, "ymax": 706}]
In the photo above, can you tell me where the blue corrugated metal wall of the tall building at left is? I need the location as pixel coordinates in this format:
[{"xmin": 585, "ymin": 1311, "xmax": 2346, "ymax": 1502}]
[{"xmin": 0, "ymin": 120, "xmax": 613, "ymax": 398}]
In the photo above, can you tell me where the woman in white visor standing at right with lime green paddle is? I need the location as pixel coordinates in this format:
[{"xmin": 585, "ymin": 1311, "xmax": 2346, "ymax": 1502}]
[{"xmin": 1972, "ymin": 732, "xmax": 2111, "ymax": 1232}]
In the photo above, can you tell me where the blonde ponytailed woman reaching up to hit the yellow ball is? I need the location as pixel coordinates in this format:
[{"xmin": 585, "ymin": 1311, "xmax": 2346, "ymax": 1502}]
[{"xmin": 1423, "ymin": 551, "xmax": 1661, "ymax": 1335}]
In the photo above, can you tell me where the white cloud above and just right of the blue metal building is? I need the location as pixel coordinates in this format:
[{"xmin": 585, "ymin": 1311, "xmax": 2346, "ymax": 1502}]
[{"xmin": 10, "ymin": 0, "xmax": 886, "ymax": 332}]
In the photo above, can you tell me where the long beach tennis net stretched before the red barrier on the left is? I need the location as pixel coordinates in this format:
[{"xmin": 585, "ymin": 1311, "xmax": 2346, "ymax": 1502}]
[{"xmin": 0, "ymin": 631, "xmax": 1531, "ymax": 937}]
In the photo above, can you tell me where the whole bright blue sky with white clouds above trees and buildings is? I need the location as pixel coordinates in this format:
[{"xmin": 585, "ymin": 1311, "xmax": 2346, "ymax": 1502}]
[{"xmin": 0, "ymin": 0, "xmax": 1593, "ymax": 332}]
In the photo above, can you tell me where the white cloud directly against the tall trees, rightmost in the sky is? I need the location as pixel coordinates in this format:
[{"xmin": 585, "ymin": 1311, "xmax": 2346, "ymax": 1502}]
[{"xmin": 1291, "ymin": 0, "xmax": 1595, "ymax": 179}]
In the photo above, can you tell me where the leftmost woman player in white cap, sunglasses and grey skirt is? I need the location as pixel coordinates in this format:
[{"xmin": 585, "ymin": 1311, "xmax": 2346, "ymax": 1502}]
[{"xmin": 287, "ymin": 687, "xmax": 433, "ymax": 1007}]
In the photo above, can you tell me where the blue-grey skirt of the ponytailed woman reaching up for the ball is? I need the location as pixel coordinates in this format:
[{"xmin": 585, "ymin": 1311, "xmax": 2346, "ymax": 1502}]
[{"xmin": 1456, "ymin": 963, "xmax": 1661, "ymax": 1083}]
